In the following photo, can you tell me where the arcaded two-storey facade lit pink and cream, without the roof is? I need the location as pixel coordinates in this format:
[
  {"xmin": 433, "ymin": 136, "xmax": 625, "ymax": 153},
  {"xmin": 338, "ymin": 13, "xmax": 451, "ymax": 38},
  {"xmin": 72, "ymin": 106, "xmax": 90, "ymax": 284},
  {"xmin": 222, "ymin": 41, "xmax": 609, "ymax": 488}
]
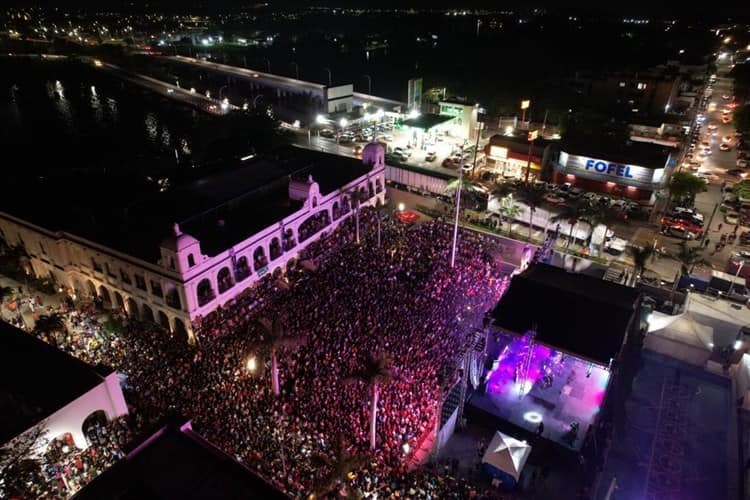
[{"xmin": 0, "ymin": 148, "xmax": 385, "ymax": 341}]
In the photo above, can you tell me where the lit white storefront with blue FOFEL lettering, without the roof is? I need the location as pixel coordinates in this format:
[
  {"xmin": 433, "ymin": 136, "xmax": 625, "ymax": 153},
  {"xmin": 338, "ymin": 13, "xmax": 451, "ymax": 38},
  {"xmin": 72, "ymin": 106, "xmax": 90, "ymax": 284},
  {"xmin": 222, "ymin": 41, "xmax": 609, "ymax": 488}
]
[{"xmin": 552, "ymin": 144, "xmax": 673, "ymax": 205}]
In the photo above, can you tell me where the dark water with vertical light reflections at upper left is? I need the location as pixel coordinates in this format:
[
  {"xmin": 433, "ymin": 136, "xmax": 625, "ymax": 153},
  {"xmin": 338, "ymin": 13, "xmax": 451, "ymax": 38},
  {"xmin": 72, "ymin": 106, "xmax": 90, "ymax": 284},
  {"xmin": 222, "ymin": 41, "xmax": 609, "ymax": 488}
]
[{"xmin": 0, "ymin": 57, "xmax": 205, "ymax": 174}]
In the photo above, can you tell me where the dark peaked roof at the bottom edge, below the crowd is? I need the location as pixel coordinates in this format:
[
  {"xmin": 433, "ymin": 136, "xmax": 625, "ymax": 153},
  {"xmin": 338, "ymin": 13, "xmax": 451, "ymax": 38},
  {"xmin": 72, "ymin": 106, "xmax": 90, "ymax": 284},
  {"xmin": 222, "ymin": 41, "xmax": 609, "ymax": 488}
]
[{"xmin": 75, "ymin": 420, "xmax": 289, "ymax": 500}]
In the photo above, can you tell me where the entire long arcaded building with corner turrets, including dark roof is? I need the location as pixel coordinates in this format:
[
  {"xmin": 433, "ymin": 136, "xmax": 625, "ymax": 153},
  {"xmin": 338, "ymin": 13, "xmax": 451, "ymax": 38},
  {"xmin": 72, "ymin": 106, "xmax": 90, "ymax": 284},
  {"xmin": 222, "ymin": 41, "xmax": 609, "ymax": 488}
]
[{"xmin": 0, "ymin": 144, "xmax": 385, "ymax": 341}]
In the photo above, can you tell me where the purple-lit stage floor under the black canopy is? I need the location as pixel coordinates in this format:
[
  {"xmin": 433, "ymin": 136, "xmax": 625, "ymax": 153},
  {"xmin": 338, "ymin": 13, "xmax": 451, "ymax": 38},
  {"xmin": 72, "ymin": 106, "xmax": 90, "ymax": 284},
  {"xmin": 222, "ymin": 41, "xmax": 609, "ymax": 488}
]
[{"xmin": 471, "ymin": 338, "xmax": 609, "ymax": 450}]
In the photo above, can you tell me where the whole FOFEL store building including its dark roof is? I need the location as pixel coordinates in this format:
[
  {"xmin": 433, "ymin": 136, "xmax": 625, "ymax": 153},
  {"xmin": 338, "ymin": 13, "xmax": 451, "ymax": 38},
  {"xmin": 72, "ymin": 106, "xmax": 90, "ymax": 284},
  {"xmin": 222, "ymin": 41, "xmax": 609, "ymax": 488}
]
[{"xmin": 550, "ymin": 141, "xmax": 677, "ymax": 205}]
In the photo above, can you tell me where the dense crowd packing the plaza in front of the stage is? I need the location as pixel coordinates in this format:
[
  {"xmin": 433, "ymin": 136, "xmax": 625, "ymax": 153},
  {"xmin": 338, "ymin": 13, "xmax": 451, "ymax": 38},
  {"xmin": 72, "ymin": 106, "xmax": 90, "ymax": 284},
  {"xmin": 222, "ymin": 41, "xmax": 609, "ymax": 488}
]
[{"xmin": 0, "ymin": 207, "xmax": 508, "ymax": 498}]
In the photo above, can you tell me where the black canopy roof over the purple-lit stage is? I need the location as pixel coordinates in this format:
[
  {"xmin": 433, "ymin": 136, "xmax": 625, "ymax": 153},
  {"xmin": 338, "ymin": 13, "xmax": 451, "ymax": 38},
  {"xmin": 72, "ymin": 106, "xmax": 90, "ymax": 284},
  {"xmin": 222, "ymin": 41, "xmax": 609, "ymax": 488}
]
[{"xmin": 492, "ymin": 264, "xmax": 640, "ymax": 365}]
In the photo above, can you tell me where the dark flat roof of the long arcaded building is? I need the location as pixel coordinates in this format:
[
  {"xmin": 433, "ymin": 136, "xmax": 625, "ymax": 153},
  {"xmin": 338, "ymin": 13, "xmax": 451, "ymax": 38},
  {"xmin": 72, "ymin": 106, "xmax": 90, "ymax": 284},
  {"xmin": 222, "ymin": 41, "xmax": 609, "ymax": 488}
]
[{"xmin": 0, "ymin": 146, "xmax": 370, "ymax": 263}]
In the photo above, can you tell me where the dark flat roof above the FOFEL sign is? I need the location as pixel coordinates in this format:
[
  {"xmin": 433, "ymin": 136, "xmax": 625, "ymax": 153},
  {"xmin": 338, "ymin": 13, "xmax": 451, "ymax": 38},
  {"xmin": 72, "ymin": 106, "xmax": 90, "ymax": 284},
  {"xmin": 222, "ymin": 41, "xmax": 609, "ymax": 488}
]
[{"xmin": 560, "ymin": 137, "xmax": 674, "ymax": 169}]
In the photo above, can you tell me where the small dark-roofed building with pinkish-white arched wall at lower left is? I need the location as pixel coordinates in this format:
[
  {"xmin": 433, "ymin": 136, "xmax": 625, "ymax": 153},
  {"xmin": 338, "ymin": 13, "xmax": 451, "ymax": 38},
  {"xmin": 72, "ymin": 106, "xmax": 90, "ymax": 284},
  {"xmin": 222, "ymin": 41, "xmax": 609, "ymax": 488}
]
[{"xmin": 0, "ymin": 321, "xmax": 128, "ymax": 454}]
